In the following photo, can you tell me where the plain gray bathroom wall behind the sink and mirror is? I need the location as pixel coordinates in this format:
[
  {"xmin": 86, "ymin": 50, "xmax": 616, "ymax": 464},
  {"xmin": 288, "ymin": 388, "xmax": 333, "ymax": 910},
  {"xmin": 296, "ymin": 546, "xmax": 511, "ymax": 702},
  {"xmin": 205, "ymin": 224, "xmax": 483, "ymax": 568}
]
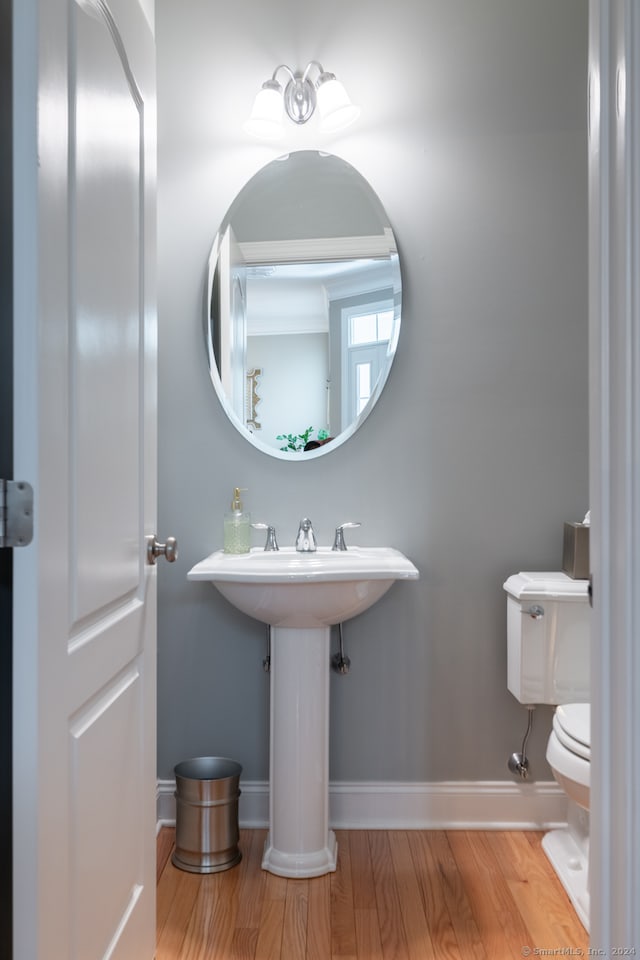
[{"xmin": 156, "ymin": 0, "xmax": 588, "ymax": 781}]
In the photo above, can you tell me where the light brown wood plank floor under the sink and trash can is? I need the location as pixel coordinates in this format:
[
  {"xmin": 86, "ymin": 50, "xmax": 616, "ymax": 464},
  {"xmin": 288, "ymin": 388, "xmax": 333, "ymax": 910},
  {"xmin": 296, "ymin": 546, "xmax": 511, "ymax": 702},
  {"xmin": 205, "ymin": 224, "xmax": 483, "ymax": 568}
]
[{"xmin": 156, "ymin": 829, "xmax": 589, "ymax": 960}]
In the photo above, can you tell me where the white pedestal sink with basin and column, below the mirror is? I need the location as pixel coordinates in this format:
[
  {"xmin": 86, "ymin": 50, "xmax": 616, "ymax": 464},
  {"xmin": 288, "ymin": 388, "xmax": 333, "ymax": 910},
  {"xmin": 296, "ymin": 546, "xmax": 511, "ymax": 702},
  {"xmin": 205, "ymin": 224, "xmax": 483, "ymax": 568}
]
[{"xmin": 187, "ymin": 547, "xmax": 419, "ymax": 877}]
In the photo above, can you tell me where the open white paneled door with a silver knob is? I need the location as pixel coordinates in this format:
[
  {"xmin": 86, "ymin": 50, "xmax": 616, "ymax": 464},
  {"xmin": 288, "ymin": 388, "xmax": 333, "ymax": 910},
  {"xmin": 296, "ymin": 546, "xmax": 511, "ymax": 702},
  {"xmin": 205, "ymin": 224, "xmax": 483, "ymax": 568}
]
[{"xmin": 14, "ymin": 0, "xmax": 156, "ymax": 960}]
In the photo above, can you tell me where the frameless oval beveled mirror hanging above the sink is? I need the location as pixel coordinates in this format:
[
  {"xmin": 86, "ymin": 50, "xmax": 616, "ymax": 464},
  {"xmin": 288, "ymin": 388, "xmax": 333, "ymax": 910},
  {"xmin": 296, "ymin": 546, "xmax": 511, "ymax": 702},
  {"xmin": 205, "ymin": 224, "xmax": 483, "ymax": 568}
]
[{"xmin": 206, "ymin": 150, "xmax": 401, "ymax": 459}]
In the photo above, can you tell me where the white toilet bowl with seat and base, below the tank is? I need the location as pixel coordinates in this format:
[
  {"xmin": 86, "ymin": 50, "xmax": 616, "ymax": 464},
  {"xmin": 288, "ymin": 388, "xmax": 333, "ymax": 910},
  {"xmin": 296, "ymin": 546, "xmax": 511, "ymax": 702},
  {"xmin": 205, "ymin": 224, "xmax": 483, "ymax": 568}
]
[{"xmin": 542, "ymin": 703, "xmax": 591, "ymax": 930}]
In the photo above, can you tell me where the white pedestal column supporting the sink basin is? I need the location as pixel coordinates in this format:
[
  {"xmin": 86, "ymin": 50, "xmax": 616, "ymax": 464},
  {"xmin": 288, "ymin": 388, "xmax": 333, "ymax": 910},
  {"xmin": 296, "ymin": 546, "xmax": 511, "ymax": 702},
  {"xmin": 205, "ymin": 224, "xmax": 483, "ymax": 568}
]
[{"xmin": 262, "ymin": 627, "xmax": 338, "ymax": 877}]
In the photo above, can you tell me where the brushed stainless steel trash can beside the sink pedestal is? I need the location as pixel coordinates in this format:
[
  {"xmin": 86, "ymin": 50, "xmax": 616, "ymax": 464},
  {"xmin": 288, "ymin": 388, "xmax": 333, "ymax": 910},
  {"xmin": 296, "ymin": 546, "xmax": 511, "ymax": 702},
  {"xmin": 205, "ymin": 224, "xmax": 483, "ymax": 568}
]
[{"xmin": 171, "ymin": 757, "xmax": 242, "ymax": 873}]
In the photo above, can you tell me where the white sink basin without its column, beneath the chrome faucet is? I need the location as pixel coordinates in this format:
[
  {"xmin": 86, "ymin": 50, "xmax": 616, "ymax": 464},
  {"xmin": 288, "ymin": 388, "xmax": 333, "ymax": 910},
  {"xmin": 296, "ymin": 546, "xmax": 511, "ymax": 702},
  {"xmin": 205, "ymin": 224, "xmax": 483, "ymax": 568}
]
[{"xmin": 188, "ymin": 547, "xmax": 418, "ymax": 627}]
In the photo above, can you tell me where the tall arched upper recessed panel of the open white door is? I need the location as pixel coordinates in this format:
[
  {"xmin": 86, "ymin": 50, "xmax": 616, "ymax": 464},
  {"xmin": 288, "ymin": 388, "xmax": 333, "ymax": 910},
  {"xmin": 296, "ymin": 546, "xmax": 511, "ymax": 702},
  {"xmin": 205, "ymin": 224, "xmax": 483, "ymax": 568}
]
[{"xmin": 71, "ymin": 4, "xmax": 144, "ymax": 622}]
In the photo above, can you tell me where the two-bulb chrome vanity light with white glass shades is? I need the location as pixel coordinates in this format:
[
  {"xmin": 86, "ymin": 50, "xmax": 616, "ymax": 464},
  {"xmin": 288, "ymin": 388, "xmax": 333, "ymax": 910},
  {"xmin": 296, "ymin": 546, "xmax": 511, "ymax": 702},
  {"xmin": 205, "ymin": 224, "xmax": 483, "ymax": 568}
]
[{"xmin": 244, "ymin": 60, "xmax": 360, "ymax": 140}]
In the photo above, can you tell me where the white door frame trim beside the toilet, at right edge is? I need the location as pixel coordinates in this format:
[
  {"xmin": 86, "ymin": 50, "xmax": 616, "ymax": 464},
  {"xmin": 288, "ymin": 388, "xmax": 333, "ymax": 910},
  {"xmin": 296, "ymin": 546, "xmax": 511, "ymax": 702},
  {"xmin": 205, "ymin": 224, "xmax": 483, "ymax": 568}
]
[{"xmin": 588, "ymin": 0, "xmax": 640, "ymax": 944}]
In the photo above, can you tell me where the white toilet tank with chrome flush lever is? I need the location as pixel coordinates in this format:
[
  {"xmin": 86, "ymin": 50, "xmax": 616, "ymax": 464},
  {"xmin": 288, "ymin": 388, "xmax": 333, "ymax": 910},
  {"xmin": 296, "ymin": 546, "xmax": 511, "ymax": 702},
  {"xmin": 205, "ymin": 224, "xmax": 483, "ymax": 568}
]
[{"xmin": 504, "ymin": 573, "xmax": 591, "ymax": 704}]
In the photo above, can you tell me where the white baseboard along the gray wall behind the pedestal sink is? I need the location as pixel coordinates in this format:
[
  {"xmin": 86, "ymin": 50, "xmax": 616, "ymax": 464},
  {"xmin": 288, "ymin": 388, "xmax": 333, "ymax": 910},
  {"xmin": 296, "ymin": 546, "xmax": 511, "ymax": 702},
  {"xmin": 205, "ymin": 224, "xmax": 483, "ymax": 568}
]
[{"xmin": 157, "ymin": 780, "xmax": 567, "ymax": 830}]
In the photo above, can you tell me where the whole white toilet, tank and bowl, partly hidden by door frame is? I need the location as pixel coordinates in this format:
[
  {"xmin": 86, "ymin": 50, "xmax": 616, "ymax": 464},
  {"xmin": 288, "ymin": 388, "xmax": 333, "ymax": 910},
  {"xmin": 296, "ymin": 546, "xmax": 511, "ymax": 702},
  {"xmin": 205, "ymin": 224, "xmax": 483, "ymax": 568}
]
[{"xmin": 504, "ymin": 573, "xmax": 591, "ymax": 930}]
